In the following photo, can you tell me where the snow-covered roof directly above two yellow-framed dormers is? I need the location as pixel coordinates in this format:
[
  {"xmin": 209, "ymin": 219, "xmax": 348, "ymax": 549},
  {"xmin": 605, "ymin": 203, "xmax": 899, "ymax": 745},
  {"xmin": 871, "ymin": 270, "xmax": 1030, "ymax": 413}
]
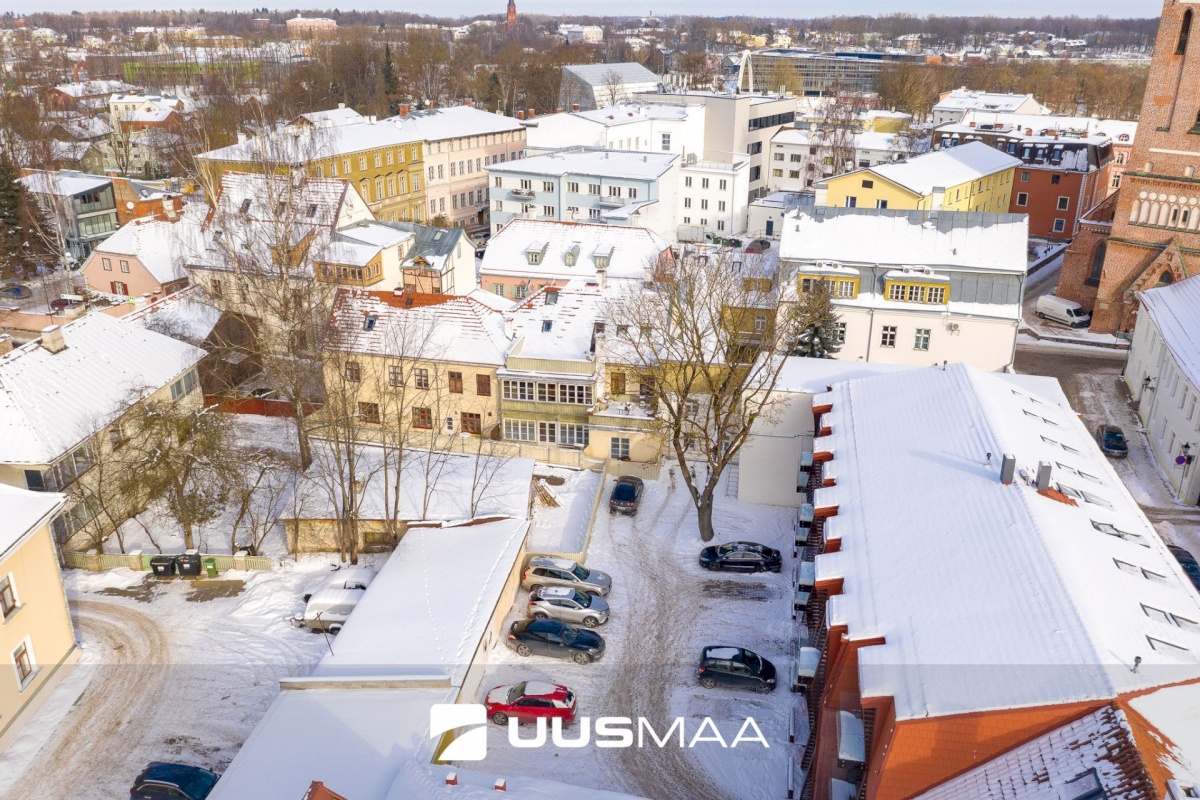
[{"xmin": 779, "ymin": 206, "xmax": 1028, "ymax": 272}]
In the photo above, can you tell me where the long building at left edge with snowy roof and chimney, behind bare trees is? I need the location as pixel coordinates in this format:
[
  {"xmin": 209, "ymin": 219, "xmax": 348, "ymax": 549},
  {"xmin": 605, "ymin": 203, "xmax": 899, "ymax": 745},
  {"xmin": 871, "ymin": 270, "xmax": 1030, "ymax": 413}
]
[{"xmin": 0, "ymin": 314, "xmax": 205, "ymax": 547}]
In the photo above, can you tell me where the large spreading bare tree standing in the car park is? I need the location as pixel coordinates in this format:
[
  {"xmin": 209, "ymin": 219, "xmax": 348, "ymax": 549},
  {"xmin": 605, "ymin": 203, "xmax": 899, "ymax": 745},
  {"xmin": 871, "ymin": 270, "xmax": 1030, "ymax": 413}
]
[{"xmin": 605, "ymin": 251, "xmax": 798, "ymax": 541}]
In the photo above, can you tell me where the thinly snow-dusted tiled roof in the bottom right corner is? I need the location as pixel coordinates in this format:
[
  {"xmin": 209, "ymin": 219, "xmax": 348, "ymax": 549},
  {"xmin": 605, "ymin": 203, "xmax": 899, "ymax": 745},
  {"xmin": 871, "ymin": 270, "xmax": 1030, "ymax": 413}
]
[{"xmin": 914, "ymin": 705, "xmax": 1157, "ymax": 800}]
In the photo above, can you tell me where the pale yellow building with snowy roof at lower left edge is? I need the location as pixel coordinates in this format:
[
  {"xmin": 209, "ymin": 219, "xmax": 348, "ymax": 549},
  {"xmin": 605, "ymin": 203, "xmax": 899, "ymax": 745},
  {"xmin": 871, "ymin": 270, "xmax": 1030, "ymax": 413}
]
[{"xmin": 0, "ymin": 483, "xmax": 79, "ymax": 752}]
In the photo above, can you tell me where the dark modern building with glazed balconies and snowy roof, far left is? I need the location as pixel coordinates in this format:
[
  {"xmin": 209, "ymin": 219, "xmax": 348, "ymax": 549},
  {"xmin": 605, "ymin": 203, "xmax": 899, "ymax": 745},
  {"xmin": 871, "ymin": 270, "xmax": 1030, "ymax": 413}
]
[{"xmin": 20, "ymin": 170, "xmax": 120, "ymax": 263}]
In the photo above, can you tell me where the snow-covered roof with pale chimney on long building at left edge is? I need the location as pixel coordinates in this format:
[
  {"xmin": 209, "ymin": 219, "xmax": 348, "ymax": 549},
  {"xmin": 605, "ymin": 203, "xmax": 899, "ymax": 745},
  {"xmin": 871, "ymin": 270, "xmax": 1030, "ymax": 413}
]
[{"xmin": 0, "ymin": 314, "xmax": 204, "ymax": 464}]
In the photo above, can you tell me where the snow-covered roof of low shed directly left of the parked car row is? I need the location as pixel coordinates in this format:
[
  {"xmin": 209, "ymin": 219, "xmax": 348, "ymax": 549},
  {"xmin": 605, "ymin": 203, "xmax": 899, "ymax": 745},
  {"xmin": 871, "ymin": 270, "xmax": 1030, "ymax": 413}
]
[{"xmin": 313, "ymin": 522, "xmax": 532, "ymax": 686}]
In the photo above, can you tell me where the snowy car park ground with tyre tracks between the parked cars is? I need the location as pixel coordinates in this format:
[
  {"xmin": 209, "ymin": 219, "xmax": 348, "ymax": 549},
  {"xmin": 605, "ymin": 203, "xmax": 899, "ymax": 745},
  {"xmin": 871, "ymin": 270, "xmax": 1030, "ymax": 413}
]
[{"xmin": 464, "ymin": 470, "xmax": 805, "ymax": 800}]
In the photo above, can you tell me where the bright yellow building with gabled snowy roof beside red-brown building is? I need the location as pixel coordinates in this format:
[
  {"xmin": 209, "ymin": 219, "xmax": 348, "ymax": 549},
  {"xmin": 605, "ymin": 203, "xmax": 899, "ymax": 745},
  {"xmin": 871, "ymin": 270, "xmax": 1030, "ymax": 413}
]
[{"xmin": 816, "ymin": 142, "xmax": 1021, "ymax": 213}]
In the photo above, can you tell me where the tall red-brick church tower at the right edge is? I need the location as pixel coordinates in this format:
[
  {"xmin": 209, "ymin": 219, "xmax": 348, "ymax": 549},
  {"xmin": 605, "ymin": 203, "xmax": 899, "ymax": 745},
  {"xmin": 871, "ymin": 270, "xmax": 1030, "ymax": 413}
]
[{"xmin": 1057, "ymin": 0, "xmax": 1200, "ymax": 333}]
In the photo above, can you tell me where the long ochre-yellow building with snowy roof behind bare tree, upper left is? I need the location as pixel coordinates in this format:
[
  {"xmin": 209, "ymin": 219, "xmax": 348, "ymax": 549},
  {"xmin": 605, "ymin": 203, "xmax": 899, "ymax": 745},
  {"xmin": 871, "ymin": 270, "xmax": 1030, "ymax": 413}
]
[{"xmin": 196, "ymin": 116, "xmax": 426, "ymax": 222}]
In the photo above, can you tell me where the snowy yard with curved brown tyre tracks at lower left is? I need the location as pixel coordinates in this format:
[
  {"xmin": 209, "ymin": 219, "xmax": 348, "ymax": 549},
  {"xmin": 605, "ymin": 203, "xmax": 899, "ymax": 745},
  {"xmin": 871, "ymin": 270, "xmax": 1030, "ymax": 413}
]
[{"xmin": 0, "ymin": 557, "xmax": 384, "ymax": 800}]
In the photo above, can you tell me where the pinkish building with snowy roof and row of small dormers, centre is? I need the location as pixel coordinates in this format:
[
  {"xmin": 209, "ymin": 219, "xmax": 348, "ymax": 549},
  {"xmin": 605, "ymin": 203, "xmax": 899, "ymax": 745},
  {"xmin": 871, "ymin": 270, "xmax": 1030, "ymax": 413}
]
[{"xmin": 480, "ymin": 218, "xmax": 674, "ymax": 300}]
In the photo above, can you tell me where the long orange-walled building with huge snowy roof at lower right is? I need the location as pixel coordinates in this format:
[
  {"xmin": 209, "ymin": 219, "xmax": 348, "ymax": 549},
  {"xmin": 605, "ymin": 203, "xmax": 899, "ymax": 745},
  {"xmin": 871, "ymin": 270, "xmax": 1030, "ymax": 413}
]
[{"xmin": 799, "ymin": 365, "xmax": 1200, "ymax": 800}]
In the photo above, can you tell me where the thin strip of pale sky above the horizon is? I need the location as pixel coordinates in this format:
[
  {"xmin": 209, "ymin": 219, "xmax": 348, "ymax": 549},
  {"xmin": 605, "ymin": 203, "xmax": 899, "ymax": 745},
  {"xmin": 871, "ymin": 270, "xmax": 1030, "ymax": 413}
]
[{"xmin": 13, "ymin": 0, "xmax": 1163, "ymax": 18}]
